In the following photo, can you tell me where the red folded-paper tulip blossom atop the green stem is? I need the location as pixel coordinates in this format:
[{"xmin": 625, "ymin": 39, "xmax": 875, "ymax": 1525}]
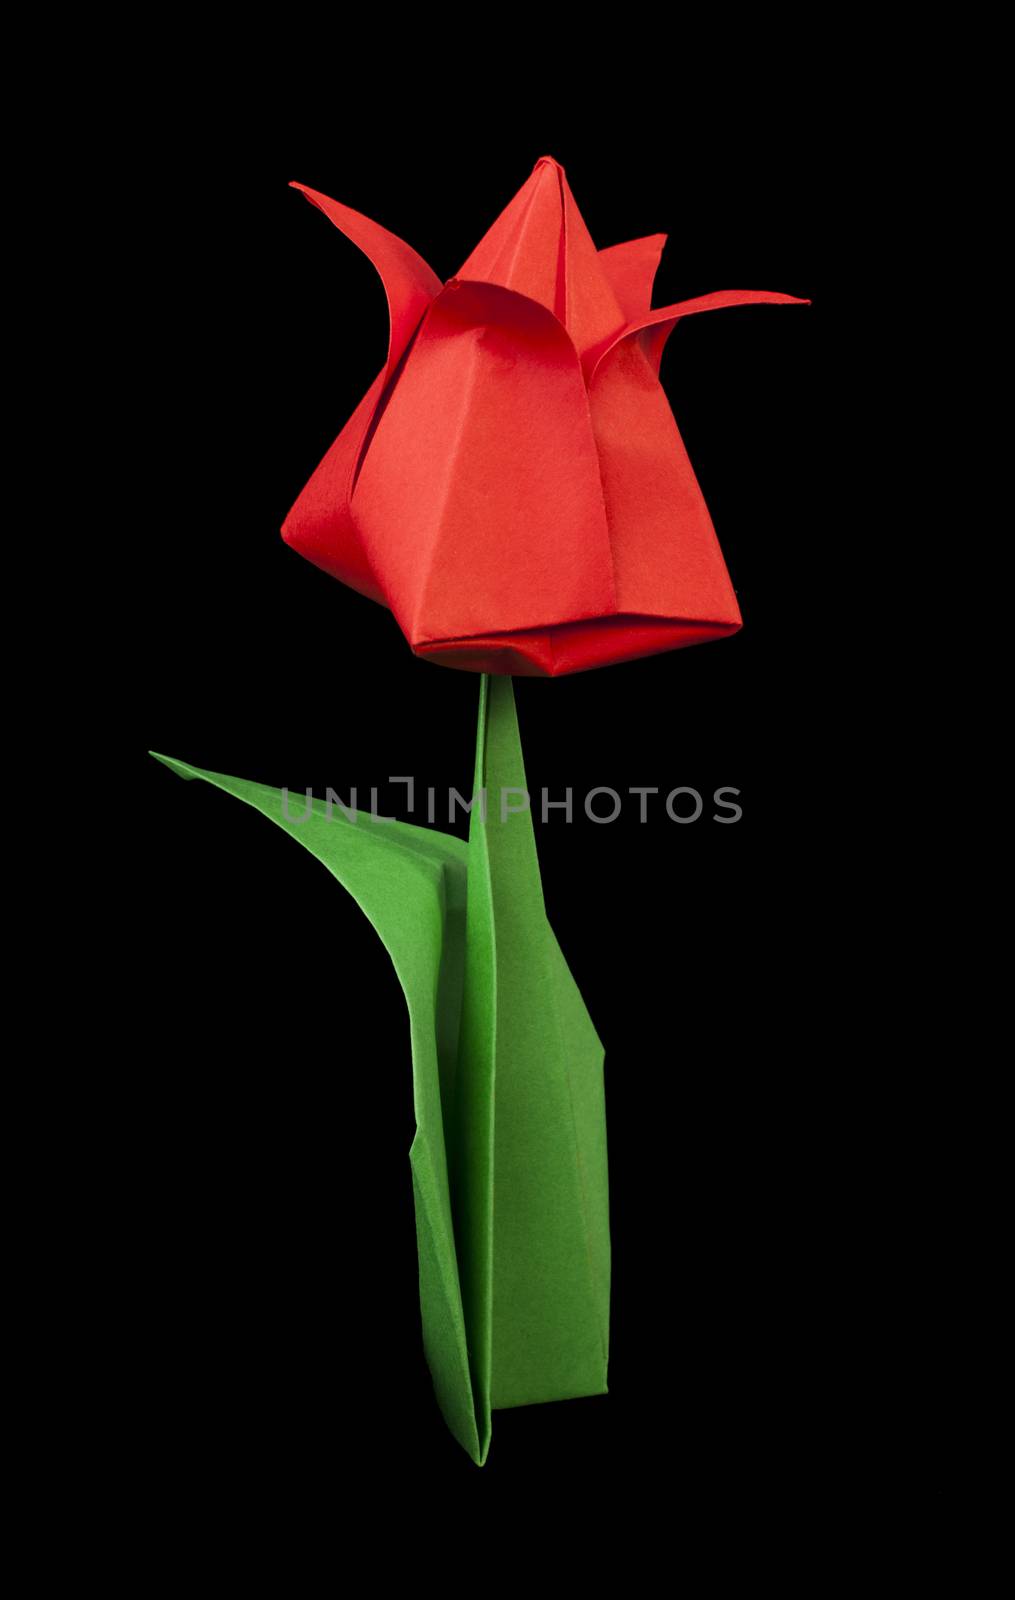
[{"xmin": 282, "ymin": 155, "xmax": 808, "ymax": 675}]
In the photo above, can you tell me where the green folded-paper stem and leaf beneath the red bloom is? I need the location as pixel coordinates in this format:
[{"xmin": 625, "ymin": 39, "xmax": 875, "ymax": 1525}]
[{"xmin": 150, "ymin": 677, "xmax": 610, "ymax": 1466}]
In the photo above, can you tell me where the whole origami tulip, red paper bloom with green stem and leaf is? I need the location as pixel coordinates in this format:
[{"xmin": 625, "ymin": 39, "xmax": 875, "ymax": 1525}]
[{"xmin": 152, "ymin": 157, "xmax": 807, "ymax": 1464}]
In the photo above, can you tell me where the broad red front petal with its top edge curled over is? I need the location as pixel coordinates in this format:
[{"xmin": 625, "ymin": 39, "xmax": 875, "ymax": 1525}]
[{"xmin": 352, "ymin": 280, "xmax": 615, "ymax": 648}]
